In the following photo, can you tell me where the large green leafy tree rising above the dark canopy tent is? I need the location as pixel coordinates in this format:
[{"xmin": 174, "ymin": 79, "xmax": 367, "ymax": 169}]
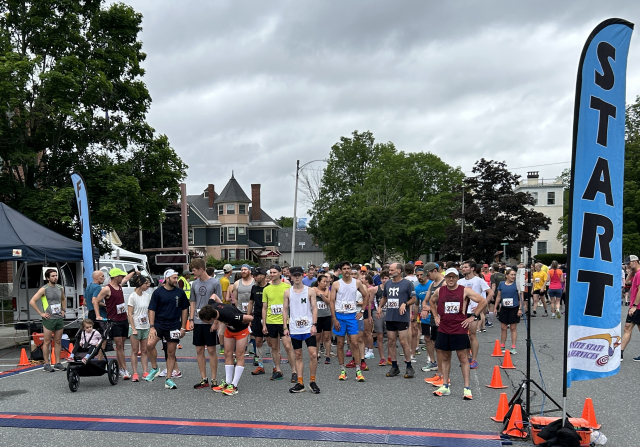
[{"xmin": 0, "ymin": 0, "xmax": 186, "ymax": 252}]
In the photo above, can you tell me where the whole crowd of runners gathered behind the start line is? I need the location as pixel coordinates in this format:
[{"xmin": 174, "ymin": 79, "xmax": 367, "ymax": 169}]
[{"xmin": 30, "ymin": 252, "xmax": 640, "ymax": 400}]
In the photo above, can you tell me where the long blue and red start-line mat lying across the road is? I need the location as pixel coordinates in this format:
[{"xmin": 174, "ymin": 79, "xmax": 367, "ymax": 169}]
[{"xmin": 0, "ymin": 412, "xmax": 502, "ymax": 447}]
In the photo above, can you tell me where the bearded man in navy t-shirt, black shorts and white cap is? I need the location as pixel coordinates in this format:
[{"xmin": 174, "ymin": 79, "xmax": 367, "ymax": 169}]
[{"xmin": 146, "ymin": 269, "xmax": 189, "ymax": 389}]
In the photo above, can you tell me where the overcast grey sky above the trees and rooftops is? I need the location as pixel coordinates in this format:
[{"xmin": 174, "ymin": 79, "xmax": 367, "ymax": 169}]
[{"xmin": 125, "ymin": 0, "xmax": 640, "ymax": 218}]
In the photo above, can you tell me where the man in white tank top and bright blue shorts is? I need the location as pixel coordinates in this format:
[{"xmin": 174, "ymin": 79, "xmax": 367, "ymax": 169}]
[{"xmin": 329, "ymin": 261, "xmax": 369, "ymax": 382}]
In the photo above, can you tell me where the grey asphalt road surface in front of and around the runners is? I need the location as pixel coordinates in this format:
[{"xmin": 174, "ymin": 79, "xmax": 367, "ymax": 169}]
[{"xmin": 0, "ymin": 307, "xmax": 640, "ymax": 446}]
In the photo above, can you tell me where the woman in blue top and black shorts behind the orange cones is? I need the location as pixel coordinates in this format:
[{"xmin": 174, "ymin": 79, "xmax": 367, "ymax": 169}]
[{"xmin": 496, "ymin": 268, "xmax": 522, "ymax": 354}]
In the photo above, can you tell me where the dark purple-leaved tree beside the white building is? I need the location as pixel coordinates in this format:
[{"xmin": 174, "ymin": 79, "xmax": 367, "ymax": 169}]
[{"xmin": 443, "ymin": 158, "xmax": 551, "ymax": 261}]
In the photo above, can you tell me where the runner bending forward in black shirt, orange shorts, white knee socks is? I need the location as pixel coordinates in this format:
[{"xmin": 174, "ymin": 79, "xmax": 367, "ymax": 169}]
[{"xmin": 198, "ymin": 302, "xmax": 253, "ymax": 396}]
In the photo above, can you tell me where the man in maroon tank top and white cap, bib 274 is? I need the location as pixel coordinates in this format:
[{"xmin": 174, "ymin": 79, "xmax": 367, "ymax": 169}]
[{"xmin": 431, "ymin": 268, "xmax": 487, "ymax": 400}]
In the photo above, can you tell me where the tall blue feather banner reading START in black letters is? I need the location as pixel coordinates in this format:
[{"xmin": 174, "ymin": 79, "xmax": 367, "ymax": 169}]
[{"xmin": 565, "ymin": 19, "xmax": 633, "ymax": 389}]
